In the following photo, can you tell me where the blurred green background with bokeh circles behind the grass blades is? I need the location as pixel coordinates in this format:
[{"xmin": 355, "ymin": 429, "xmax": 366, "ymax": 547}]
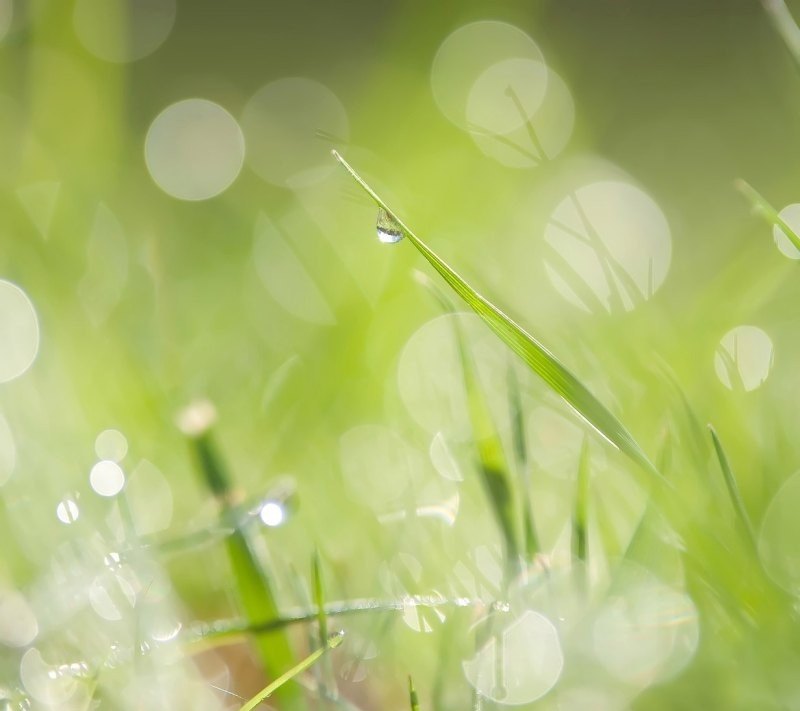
[{"xmin": 0, "ymin": 0, "xmax": 800, "ymax": 709}]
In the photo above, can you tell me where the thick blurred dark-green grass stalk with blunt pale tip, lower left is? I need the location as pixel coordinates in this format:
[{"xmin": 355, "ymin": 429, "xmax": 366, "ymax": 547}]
[{"xmin": 181, "ymin": 403, "xmax": 303, "ymax": 708}]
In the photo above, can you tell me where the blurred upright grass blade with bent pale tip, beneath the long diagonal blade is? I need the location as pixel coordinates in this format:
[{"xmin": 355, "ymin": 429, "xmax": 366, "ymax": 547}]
[{"xmin": 418, "ymin": 275, "xmax": 520, "ymax": 575}]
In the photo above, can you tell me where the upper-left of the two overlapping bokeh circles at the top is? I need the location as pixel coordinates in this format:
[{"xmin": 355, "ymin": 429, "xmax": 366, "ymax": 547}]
[{"xmin": 431, "ymin": 20, "xmax": 544, "ymax": 129}]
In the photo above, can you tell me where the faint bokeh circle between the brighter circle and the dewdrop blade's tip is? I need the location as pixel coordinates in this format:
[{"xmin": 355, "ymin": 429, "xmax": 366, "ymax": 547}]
[{"xmin": 242, "ymin": 77, "xmax": 350, "ymax": 188}]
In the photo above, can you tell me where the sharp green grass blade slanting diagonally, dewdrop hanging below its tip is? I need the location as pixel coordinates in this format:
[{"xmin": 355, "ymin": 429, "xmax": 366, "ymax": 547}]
[{"xmin": 333, "ymin": 151, "xmax": 660, "ymax": 477}]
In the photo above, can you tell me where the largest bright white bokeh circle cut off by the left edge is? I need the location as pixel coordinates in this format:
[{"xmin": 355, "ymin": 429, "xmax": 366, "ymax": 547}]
[{"xmin": 0, "ymin": 279, "xmax": 39, "ymax": 383}]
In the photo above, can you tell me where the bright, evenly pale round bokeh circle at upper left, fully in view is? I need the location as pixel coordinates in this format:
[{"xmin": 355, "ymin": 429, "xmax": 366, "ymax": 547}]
[{"xmin": 145, "ymin": 99, "xmax": 245, "ymax": 200}]
